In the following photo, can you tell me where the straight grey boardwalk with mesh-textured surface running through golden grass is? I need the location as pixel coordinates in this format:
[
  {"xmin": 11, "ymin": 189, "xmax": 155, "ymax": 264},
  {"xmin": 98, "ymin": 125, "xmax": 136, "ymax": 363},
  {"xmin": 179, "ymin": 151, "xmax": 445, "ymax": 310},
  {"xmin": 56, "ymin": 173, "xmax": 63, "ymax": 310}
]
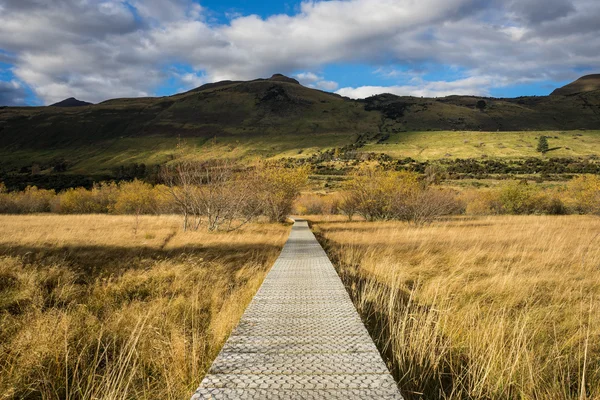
[{"xmin": 192, "ymin": 221, "xmax": 402, "ymax": 400}]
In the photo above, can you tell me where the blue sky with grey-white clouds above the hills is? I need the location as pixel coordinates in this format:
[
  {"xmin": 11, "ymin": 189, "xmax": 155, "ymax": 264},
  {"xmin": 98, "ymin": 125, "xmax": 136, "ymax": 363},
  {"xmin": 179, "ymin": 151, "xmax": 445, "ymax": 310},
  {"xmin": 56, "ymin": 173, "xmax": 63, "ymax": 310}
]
[{"xmin": 0, "ymin": 0, "xmax": 600, "ymax": 105}]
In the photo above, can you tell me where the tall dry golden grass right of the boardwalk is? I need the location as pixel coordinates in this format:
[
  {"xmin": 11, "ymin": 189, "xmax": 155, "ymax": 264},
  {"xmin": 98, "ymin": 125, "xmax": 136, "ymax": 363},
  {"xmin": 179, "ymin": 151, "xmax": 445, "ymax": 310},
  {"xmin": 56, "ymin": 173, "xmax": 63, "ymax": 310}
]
[{"xmin": 312, "ymin": 216, "xmax": 600, "ymax": 400}]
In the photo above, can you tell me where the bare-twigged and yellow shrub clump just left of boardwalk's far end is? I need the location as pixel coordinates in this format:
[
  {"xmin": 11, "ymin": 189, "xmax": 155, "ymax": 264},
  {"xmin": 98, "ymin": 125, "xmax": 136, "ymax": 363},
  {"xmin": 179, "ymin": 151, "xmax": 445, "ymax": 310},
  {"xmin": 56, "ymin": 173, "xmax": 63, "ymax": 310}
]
[{"xmin": 163, "ymin": 160, "xmax": 296, "ymax": 231}]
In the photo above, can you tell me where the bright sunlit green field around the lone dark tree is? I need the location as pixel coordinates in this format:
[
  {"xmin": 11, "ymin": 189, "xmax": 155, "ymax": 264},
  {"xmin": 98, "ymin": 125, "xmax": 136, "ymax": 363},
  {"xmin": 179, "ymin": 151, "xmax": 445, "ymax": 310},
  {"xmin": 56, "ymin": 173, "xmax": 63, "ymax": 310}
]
[{"xmin": 363, "ymin": 131, "xmax": 600, "ymax": 160}]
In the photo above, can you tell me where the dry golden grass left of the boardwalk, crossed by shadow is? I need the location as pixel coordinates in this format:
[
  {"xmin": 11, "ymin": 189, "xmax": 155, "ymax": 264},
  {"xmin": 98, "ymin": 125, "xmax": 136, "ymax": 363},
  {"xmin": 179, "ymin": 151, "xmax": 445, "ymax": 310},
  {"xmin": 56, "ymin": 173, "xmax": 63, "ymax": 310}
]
[{"xmin": 0, "ymin": 215, "xmax": 289, "ymax": 399}]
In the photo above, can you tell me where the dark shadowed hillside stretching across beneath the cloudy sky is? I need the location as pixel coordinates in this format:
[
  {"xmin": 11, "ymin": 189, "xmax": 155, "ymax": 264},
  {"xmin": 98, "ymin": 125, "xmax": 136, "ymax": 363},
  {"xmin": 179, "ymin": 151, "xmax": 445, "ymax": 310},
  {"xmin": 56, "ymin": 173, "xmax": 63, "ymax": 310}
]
[{"xmin": 0, "ymin": 75, "xmax": 600, "ymax": 186}]
